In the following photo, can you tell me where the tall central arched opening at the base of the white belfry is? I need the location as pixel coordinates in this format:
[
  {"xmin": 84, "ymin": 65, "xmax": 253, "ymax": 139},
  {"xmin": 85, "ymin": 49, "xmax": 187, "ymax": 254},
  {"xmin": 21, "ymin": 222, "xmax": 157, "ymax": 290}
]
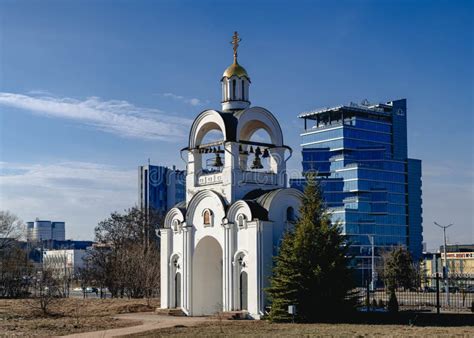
[{"xmin": 192, "ymin": 236, "xmax": 223, "ymax": 316}]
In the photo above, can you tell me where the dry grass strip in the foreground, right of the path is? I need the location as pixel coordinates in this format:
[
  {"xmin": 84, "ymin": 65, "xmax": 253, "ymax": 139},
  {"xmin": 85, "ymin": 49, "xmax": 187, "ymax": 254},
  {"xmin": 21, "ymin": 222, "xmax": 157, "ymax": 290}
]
[{"xmin": 130, "ymin": 321, "xmax": 474, "ymax": 338}]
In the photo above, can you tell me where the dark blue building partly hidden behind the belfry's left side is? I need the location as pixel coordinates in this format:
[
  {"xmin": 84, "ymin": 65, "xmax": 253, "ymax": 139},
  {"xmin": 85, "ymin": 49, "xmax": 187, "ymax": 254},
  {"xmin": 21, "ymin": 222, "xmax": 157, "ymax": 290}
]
[{"xmin": 138, "ymin": 164, "xmax": 186, "ymax": 214}]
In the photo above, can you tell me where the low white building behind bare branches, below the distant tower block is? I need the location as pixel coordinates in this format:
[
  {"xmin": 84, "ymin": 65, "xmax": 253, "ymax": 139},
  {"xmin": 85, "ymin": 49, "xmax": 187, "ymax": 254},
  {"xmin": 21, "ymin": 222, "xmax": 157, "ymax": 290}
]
[{"xmin": 43, "ymin": 249, "xmax": 87, "ymax": 278}]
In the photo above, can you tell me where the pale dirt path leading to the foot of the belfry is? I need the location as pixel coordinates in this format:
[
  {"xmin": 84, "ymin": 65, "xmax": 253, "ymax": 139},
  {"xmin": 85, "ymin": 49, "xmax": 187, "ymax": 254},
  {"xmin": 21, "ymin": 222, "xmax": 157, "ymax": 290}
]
[{"xmin": 64, "ymin": 312, "xmax": 212, "ymax": 338}]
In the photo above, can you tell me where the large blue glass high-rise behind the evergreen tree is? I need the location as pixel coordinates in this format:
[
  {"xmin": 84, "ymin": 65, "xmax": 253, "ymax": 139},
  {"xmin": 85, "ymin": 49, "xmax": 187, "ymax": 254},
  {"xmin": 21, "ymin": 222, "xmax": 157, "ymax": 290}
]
[{"xmin": 290, "ymin": 99, "xmax": 422, "ymax": 281}]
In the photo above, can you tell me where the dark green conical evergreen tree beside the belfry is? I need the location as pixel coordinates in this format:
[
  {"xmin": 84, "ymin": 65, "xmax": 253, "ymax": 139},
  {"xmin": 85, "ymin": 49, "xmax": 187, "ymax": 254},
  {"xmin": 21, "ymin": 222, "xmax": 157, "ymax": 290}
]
[{"xmin": 267, "ymin": 175, "xmax": 356, "ymax": 322}]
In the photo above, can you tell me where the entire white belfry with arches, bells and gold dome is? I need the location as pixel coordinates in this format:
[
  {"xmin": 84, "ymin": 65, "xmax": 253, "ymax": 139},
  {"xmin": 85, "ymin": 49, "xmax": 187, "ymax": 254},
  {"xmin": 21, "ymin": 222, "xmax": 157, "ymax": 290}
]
[{"xmin": 160, "ymin": 32, "xmax": 302, "ymax": 319}]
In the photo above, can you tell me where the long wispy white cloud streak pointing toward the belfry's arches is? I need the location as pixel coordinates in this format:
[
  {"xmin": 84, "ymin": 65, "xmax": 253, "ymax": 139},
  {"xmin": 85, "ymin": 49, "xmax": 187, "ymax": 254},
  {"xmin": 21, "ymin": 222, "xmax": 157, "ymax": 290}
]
[{"xmin": 0, "ymin": 91, "xmax": 192, "ymax": 142}]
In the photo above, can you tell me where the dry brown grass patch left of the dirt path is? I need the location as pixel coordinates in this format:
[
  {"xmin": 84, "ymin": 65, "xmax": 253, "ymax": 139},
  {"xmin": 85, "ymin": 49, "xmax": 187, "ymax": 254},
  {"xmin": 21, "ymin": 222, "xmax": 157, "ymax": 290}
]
[{"xmin": 0, "ymin": 298, "xmax": 158, "ymax": 336}]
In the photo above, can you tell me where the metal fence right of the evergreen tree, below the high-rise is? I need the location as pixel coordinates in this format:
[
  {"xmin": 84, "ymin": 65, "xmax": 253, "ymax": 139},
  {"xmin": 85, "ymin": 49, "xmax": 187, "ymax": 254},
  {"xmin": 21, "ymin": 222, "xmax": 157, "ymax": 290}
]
[{"xmin": 359, "ymin": 275, "xmax": 474, "ymax": 313}]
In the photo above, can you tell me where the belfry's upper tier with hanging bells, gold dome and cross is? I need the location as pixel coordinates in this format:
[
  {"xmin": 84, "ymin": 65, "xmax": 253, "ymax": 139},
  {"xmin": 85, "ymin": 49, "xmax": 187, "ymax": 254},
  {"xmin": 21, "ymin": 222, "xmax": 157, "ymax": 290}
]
[{"xmin": 182, "ymin": 32, "xmax": 292, "ymax": 203}]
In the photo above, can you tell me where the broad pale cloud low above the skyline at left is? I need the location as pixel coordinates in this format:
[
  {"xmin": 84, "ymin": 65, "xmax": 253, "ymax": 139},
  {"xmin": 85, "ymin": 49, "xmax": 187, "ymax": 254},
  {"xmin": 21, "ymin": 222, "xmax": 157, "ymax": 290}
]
[{"xmin": 0, "ymin": 162, "xmax": 138, "ymax": 239}]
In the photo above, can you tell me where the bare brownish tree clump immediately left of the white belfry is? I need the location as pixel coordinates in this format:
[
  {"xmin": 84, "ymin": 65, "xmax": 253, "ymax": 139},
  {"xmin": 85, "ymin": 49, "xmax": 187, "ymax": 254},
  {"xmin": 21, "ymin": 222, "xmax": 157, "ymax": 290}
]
[{"xmin": 79, "ymin": 208, "xmax": 162, "ymax": 303}]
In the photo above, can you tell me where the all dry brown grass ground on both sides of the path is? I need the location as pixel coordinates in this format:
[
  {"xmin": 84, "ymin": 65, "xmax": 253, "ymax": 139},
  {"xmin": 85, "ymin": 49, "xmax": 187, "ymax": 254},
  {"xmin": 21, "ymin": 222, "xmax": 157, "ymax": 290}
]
[{"xmin": 0, "ymin": 298, "xmax": 474, "ymax": 338}]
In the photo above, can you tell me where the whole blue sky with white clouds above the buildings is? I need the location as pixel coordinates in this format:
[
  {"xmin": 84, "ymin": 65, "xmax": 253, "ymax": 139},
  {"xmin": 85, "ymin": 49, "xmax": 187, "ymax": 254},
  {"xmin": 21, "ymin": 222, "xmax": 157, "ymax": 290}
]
[{"xmin": 0, "ymin": 0, "xmax": 474, "ymax": 248}]
